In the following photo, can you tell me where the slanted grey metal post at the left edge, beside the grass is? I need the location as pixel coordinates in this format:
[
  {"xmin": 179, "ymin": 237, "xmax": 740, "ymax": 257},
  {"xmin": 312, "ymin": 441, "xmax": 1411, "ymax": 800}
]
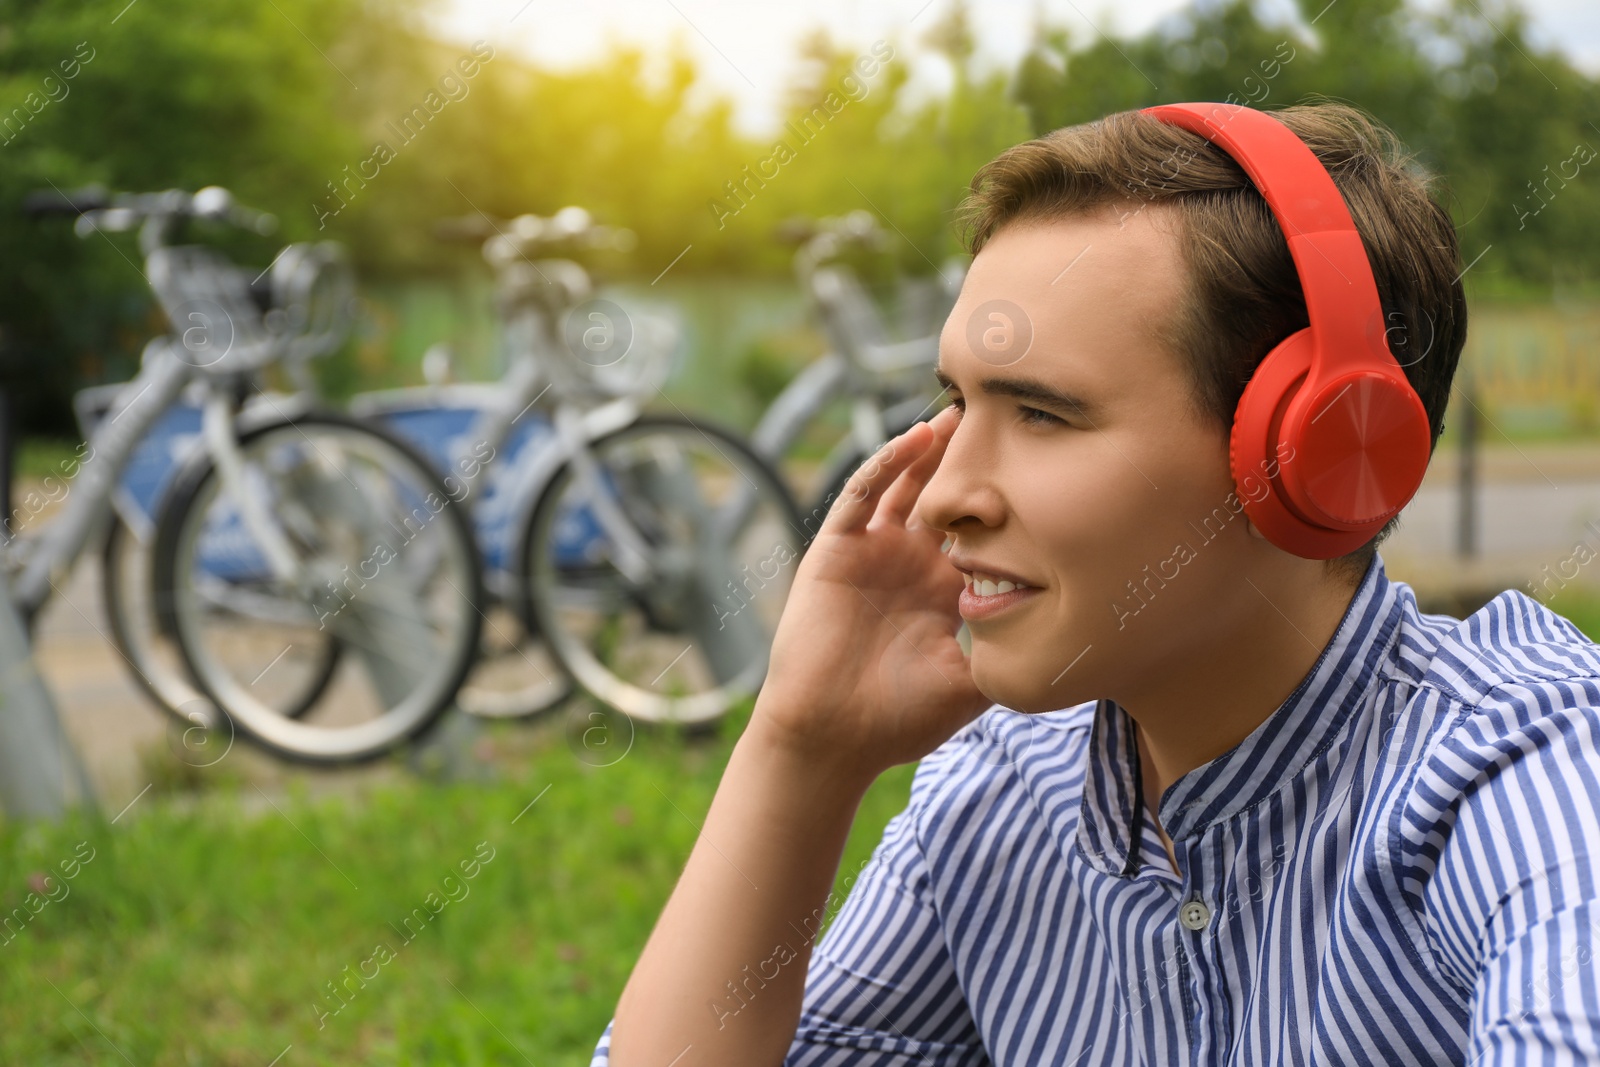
[{"xmin": 0, "ymin": 571, "xmax": 94, "ymax": 819}]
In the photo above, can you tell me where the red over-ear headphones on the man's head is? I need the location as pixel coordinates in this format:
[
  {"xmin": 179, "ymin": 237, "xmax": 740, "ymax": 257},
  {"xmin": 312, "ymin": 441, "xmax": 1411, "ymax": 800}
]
[{"xmin": 1141, "ymin": 102, "xmax": 1432, "ymax": 560}]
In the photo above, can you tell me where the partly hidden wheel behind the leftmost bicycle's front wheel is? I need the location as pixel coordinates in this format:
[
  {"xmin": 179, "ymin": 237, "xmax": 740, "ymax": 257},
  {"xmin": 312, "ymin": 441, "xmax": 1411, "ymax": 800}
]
[{"xmin": 101, "ymin": 515, "xmax": 339, "ymax": 726}]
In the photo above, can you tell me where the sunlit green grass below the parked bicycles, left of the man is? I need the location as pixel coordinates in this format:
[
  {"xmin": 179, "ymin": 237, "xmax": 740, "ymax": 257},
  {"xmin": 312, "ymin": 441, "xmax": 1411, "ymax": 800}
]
[{"xmin": 0, "ymin": 705, "xmax": 914, "ymax": 1067}]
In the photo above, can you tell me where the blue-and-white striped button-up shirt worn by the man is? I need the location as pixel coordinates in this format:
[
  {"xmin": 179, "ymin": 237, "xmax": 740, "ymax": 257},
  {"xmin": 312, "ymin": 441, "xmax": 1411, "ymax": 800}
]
[{"xmin": 592, "ymin": 557, "xmax": 1600, "ymax": 1067}]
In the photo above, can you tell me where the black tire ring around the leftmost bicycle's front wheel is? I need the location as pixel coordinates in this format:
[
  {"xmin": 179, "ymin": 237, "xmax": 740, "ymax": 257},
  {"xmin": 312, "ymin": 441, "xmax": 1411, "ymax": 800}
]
[{"xmin": 154, "ymin": 411, "xmax": 485, "ymax": 765}]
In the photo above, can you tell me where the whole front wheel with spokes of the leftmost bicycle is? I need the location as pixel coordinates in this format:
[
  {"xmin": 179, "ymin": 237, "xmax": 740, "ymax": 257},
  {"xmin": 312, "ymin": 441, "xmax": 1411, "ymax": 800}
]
[{"xmin": 155, "ymin": 413, "xmax": 483, "ymax": 763}]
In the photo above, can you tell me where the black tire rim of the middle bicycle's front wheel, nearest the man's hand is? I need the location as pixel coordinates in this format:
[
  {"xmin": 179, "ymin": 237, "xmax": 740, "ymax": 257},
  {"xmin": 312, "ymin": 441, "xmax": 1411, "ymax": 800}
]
[{"xmin": 512, "ymin": 414, "xmax": 800, "ymax": 728}]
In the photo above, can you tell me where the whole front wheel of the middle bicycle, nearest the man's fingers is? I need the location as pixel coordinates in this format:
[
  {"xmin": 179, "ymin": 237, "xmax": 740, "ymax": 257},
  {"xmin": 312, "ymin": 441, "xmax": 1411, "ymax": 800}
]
[{"xmin": 514, "ymin": 416, "xmax": 802, "ymax": 723}]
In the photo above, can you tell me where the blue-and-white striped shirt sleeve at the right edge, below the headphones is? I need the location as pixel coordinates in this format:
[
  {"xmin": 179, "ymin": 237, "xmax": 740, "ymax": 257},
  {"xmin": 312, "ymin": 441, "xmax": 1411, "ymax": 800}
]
[{"xmin": 1422, "ymin": 683, "xmax": 1600, "ymax": 1067}]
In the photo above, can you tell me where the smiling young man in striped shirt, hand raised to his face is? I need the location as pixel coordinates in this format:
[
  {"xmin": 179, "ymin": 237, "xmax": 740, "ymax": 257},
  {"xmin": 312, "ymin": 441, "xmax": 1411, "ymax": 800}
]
[{"xmin": 594, "ymin": 104, "xmax": 1600, "ymax": 1067}]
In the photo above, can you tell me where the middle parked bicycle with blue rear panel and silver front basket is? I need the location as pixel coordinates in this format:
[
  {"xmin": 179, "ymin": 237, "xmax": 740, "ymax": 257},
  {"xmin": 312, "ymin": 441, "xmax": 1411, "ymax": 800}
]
[{"xmin": 350, "ymin": 208, "xmax": 800, "ymax": 725}]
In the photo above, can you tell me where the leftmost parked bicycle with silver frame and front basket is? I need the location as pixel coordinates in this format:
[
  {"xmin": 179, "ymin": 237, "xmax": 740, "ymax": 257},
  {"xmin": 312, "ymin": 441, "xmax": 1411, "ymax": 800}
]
[{"xmin": 18, "ymin": 186, "xmax": 482, "ymax": 763}]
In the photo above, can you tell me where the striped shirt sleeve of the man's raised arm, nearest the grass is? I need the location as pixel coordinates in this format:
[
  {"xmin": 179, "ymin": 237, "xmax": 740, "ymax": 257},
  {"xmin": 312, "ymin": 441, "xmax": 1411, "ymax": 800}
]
[{"xmin": 590, "ymin": 726, "xmax": 990, "ymax": 1067}]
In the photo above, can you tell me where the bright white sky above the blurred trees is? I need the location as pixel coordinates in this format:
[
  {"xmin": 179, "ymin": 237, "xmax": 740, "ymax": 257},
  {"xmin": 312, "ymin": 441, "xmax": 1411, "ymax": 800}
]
[{"xmin": 435, "ymin": 0, "xmax": 1600, "ymax": 133}]
